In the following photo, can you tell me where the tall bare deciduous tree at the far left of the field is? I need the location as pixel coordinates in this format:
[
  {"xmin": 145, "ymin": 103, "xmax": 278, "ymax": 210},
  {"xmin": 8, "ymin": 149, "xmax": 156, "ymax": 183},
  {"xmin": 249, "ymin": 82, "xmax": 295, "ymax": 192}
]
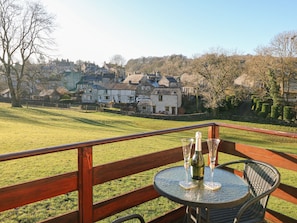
[{"xmin": 0, "ymin": 0, "xmax": 55, "ymax": 107}]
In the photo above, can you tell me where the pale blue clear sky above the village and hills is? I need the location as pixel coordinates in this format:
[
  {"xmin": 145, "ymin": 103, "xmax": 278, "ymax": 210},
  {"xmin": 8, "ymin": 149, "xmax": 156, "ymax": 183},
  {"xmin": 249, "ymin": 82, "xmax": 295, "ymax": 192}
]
[{"xmin": 40, "ymin": 0, "xmax": 297, "ymax": 65}]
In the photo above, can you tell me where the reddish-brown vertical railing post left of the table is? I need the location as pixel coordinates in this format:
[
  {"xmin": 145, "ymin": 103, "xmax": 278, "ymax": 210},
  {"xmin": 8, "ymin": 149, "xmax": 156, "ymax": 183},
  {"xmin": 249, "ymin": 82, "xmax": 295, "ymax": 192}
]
[{"xmin": 78, "ymin": 147, "xmax": 93, "ymax": 223}]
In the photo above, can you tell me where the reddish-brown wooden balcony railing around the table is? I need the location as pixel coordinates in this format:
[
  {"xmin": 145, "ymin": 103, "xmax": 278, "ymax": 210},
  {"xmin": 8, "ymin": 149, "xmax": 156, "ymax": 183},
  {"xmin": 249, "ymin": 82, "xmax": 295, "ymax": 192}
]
[{"xmin": 0, "ymin": 123, "xmax": 297, "ymax": 223}]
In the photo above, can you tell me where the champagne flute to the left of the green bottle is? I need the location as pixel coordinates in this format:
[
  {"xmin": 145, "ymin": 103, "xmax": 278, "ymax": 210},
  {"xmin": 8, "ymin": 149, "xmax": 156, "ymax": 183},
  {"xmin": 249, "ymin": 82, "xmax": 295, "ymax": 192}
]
[{"xmin": 179, "ymin": 138, "xmax": 197, "ymax": 189}]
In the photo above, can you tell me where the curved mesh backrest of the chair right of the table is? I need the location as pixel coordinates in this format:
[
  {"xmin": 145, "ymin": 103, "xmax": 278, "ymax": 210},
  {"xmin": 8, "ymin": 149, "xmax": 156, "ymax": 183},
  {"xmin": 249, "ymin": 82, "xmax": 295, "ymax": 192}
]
[{"xmin": 243, "ymin": 160, "xmax": 280, "ymax": 209}]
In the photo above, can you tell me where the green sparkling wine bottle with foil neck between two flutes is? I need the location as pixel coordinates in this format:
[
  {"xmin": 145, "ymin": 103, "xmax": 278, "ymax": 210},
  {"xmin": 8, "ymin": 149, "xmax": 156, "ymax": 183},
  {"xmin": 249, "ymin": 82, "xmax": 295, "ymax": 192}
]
[{"xmin": 191, "ymin": 132, "xmax": 205, "ymax": 180}]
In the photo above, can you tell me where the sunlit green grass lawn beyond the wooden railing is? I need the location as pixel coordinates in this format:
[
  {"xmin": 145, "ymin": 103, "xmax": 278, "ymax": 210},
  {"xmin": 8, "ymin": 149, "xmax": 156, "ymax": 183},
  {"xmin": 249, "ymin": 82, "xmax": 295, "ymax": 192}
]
[{"xmin": 0, "ymin": 103, "xmax": 297, "ymax": 223}]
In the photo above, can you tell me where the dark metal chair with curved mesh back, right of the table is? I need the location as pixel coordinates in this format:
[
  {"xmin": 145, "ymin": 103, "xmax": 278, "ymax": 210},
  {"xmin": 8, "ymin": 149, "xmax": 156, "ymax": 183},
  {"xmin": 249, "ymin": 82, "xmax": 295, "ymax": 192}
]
[{"xmin": 202, "ymin": 160, "xmax": 280, "ymax": 223}]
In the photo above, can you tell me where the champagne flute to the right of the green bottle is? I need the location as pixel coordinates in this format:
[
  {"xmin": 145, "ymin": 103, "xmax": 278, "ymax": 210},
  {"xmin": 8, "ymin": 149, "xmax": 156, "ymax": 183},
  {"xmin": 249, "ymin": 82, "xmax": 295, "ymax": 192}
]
[{"xmin": 204, "ymin": 138, "xmax": 221, "ymax": 190}]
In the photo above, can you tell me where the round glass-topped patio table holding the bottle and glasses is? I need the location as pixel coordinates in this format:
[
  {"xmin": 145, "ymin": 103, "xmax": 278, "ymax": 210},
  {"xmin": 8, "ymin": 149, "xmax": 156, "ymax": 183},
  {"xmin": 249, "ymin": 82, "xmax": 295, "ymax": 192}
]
[{"xmin": 154, "ymin": 166, "xmax": 249, "ymax": 222}]
